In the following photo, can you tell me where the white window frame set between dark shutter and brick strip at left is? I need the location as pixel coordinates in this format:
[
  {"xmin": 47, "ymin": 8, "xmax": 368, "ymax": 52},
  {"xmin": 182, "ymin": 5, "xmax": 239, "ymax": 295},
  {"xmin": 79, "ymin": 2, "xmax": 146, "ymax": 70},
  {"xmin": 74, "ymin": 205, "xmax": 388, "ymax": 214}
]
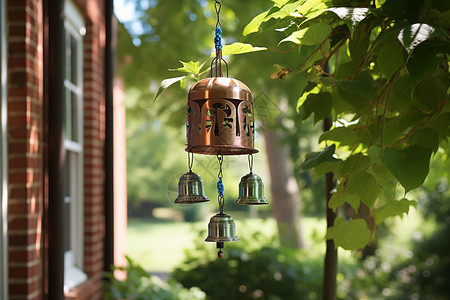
[{"xmin": 64, "ymin": 0, "xmax": 87, "ymax": 292}]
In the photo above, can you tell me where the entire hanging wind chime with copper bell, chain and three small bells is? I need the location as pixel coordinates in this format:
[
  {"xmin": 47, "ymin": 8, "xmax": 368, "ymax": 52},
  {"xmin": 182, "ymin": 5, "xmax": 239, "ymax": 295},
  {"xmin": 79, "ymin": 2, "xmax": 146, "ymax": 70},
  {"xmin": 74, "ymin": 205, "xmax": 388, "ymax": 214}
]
[{"xmin": 175, "ymin": 0, "xmax": 267, "ymax": 258}]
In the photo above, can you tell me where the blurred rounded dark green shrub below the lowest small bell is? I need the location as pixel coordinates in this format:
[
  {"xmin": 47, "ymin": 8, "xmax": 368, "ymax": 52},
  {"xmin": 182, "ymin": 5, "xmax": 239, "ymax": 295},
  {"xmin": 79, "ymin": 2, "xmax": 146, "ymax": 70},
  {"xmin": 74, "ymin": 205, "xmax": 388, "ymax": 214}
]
[{"xmin": 172, "ymin": 227, "xmax": 322, "ymax": 300}]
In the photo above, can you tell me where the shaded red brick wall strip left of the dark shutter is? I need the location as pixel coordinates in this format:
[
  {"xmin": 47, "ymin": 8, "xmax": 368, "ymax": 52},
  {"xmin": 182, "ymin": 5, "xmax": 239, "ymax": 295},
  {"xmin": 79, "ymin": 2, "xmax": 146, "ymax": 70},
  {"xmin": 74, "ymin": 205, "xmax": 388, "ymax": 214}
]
[{"xmin": 7, "ymin": 0, "xmax": 43, "ymax": 299}]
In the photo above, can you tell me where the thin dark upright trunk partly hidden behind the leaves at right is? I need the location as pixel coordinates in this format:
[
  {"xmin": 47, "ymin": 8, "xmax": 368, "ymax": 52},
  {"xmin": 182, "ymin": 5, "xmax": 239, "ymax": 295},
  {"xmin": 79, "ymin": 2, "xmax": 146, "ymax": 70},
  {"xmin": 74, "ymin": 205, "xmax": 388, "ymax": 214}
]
[{"xmin": 322, "ymin": 118, "xmax": 338, "ymax": 300}]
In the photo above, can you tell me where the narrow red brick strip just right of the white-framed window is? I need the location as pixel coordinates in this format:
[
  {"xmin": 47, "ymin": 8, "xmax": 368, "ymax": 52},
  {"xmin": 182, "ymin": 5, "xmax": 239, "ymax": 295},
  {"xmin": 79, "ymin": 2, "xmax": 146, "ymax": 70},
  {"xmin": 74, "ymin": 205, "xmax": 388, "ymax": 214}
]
[{"xmin": 80, "ymin": 0, "xmax": 105, "ymax": 299}]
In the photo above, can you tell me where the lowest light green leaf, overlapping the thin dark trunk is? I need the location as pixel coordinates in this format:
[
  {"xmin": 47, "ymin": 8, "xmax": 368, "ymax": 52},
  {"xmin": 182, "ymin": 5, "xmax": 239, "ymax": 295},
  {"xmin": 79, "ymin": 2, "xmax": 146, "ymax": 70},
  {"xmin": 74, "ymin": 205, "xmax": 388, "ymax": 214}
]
[{"xmin": 327, "ymin": 217, "xmax": 370, "ymax": 250}]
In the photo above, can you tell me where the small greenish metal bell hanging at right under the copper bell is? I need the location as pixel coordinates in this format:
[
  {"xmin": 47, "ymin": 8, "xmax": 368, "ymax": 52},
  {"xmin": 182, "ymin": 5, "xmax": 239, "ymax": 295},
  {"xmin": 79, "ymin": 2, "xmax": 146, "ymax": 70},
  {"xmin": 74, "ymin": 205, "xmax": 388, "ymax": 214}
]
[{"xmin": 234, "ymin": 172, "xmax": 268, "ymax": 205}]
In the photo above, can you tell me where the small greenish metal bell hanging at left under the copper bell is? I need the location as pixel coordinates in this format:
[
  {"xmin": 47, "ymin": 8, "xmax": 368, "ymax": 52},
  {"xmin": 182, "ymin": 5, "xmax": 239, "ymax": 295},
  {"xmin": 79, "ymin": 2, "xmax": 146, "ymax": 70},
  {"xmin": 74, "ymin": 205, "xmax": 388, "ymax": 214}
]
[{"xmin": 175, "ymin": 171, "xmax": 209, "ymax": 204}]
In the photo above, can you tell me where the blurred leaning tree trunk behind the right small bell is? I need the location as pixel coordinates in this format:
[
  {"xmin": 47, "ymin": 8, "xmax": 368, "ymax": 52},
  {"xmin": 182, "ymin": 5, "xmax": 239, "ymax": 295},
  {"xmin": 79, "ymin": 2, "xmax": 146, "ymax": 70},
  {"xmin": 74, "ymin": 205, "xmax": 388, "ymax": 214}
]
[{"xmin": 264, "ymin": 128, "xmax": 304, "ymax": 248}]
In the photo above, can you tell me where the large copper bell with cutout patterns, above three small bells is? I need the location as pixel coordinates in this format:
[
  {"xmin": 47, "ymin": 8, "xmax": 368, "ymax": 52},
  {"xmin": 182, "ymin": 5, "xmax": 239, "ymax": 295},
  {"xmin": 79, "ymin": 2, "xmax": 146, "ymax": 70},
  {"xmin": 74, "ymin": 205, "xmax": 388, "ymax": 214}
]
[{"xmin": 186, "ymin": 77, "xmax": 258, "ymax": 155}]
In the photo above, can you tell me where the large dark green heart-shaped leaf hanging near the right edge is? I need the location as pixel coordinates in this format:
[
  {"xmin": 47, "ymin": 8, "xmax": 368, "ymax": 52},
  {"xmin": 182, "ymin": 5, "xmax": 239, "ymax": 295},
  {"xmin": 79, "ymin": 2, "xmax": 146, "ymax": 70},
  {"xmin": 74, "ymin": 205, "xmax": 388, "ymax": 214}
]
[{"xmin": 384, "ymin": 145, "xmax": 432, "ymax": 192}]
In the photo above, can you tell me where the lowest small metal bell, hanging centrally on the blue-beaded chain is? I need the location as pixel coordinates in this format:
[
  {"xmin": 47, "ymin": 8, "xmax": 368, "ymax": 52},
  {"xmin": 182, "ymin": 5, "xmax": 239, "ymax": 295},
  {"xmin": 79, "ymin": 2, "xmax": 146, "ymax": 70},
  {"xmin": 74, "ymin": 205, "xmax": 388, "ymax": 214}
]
[{"xmin": 205, "ymin": 214, "xmax": 239, "ymax": 243}]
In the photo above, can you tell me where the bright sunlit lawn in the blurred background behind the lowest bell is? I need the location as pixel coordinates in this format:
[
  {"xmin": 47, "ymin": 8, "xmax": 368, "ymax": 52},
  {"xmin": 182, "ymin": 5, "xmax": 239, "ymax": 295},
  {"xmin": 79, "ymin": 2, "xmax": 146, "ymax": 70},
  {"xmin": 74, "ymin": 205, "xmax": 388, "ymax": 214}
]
[{"xmin": 127, "ymin": 218, "xmax": 325, "ymax": 273}]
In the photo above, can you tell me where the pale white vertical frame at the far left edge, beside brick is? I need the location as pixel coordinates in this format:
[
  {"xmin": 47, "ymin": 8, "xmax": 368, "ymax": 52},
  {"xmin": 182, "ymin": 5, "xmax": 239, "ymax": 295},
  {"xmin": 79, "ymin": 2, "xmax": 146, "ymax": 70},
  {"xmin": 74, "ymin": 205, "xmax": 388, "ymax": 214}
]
[{"xmin": 0, "ymin": 1, "xmax": 8, "ymax": 299}]
